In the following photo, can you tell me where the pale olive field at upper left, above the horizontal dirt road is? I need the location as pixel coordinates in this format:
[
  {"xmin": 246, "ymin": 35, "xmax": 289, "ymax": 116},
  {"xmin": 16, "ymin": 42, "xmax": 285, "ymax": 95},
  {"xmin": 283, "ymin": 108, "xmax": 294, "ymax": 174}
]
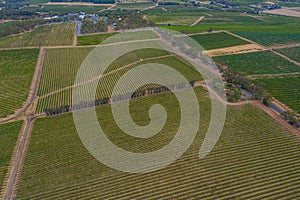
[{"xmin": 0, "ymin": 22, "xmax": 75, "ymax": 48}]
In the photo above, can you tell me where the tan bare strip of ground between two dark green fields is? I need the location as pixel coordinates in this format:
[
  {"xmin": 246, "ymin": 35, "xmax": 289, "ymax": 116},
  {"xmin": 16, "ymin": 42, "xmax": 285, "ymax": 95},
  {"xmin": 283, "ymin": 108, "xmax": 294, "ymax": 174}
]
[{"xmin": 206, "ymin": 44, "xmax": 266, "ymax": 56}]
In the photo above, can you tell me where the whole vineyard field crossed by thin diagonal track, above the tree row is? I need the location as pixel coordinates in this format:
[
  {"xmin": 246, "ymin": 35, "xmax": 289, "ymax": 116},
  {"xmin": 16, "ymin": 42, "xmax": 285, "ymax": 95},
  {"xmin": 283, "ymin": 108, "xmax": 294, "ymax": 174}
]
[{"xmin": 37, "ymin": 48, "xmax": 202, "ymax": 113}]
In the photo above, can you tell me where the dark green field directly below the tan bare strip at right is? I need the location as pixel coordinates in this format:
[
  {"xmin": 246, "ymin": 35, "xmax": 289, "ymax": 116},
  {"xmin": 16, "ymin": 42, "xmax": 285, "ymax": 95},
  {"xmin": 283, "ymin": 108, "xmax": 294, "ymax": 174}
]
[{"xmin": 214, "ymin": 51, "xmax": 300, "ymax": 75}]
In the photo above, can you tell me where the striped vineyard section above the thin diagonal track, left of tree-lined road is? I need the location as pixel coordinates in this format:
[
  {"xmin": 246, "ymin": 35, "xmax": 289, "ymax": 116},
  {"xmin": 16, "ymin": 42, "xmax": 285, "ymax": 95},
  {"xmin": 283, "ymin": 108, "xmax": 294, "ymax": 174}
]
[{"xmin": 38, "ymin": 48, "xmax": 166, "ymax": 96}]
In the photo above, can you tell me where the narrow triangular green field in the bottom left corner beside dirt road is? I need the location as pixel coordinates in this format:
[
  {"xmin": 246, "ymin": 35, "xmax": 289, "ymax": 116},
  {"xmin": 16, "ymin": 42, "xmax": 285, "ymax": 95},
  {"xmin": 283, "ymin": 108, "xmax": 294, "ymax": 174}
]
[{"xmin": 0, "ymin": 121, "xmax": 23, "ymax": 190}]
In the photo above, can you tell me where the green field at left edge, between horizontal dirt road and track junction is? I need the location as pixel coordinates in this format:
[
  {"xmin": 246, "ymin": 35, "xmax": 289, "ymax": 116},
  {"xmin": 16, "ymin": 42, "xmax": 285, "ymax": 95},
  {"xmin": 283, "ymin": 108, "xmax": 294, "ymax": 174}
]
[{"xmin": 0, "ymin": 49, "xmax": 39, "ymax": 118}]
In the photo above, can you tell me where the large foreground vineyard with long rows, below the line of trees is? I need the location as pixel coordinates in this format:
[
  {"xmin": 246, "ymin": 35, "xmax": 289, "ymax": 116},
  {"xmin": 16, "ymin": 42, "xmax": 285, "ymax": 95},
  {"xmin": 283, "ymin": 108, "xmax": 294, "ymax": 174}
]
[{"xmin": 17, "ymin": 88, "xmax": 300, "ymax": 199}]
